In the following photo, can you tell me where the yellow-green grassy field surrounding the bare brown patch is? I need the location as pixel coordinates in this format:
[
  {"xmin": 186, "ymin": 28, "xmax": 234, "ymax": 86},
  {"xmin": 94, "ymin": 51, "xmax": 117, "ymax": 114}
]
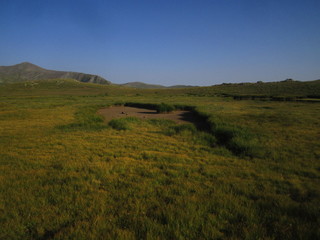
[{"xmin": 0, "ymin": 80, "xmax": 320, "ymax": 239}]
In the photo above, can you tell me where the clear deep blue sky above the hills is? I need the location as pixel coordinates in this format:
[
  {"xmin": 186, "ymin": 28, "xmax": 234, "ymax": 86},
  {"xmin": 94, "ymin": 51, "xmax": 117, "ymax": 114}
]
[{"xmin": 0, "ymin": 0, "xmax": 320, "ymax": 85}]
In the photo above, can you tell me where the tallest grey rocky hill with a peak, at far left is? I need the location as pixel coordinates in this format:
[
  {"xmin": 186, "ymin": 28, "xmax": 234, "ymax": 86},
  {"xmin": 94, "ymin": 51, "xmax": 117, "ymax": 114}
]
[{"xmin": 0, "ymin": 62, "xmax": 111, "ymax": 84}]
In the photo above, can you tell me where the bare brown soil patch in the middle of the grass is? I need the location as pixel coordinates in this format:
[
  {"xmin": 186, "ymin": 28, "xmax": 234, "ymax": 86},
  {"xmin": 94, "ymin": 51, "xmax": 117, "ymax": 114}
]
[{"xmin": 98, "ymin": 106, "xmax": 195, "ymax": 123}]
